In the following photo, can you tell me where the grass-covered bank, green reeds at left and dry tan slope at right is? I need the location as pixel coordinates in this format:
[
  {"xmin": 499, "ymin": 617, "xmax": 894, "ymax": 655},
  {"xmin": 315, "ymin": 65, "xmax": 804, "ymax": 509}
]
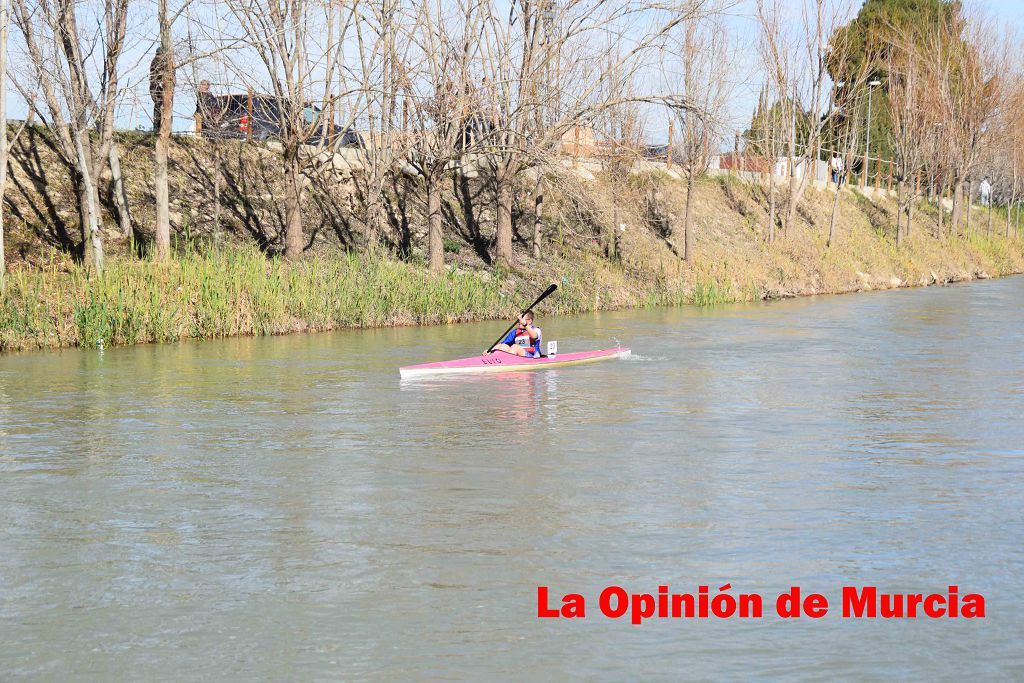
[{"xmin": 6, "ymin": 166, "xmax": 1024, "ymax": 351}]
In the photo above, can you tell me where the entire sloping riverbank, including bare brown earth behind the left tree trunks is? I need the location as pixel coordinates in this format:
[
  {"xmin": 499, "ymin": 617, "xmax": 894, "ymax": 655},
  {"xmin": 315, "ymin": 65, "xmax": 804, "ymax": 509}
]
[{"xmin": 0, "ymin": 137, "xmax": 1024, "ymax": 351}]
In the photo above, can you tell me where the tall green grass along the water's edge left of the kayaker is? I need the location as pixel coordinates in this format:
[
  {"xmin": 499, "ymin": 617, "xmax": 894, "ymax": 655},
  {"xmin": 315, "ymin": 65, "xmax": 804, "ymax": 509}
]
[{"xmin": 0, "ymin": 249, "xmax": 514, "ymax": 350}]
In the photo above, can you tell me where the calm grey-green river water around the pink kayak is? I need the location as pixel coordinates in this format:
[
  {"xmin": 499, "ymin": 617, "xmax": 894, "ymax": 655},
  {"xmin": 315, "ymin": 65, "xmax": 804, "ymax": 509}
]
[{"xmin": 0, "ymin": 278, "xmax": 1024, "ymax": 680}]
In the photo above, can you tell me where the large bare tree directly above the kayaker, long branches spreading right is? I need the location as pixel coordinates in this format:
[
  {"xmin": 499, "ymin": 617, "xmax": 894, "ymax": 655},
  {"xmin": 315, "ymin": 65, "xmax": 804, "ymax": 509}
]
[{"xmin": 481, "ymin": 0, "xmax": 707, "ymax": 263}]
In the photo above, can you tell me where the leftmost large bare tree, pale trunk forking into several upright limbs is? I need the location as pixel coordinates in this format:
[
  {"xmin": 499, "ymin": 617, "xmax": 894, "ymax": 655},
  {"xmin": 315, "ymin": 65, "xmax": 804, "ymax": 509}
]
[{"xmin": 13, "ymin": 0, "xmax": 128, "ymax": 270}]
